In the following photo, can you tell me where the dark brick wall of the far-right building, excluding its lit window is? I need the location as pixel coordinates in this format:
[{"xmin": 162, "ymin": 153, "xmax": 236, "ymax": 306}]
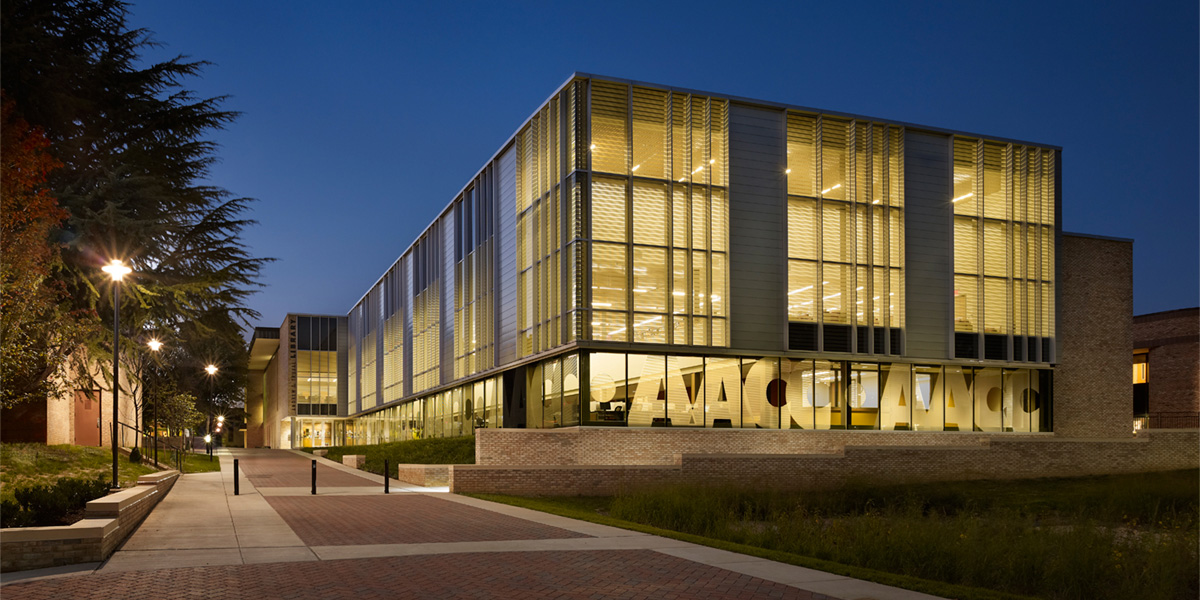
[{"xmin": 1133, "ymin": 308, "xmax": 1200, "ymax": 420}]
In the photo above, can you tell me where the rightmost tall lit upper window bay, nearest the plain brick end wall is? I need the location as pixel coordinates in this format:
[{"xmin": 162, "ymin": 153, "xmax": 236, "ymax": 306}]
[{"xmin": 950, "ymin": 138, "xmax": 1057, "ymax": 362}]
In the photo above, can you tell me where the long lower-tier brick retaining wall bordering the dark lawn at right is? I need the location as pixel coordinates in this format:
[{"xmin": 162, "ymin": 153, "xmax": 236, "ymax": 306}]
[{"xmin": 450, "ymin": 430, "xmax": 1200, "ymax": 496}]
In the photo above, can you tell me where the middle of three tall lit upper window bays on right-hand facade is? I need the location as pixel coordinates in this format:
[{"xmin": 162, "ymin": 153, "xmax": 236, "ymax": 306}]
[{"xmin": 785, "ymin": 113, "xmax": 904, "ymax": 354}]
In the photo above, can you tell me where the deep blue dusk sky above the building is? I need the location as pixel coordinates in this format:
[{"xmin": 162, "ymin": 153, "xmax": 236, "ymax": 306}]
[{"xmin": 130, "ymin": 0, "xmax": 1200, "ymax": 326}]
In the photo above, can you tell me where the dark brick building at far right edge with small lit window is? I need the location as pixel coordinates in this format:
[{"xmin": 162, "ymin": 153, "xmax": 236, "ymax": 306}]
[{"xmin": 1133, "ymin": 308, "xmax": 1200, "ymax": 428}]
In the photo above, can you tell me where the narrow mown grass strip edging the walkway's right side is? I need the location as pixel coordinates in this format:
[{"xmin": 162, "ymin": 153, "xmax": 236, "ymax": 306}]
[{"xmin": 463, "ymin": 493, "xmax": 1036, "ymax": 600}]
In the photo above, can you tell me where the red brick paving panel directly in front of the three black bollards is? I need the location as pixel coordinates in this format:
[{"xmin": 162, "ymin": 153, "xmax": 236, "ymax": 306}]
[{"xmin": 266, "ymin": 494, "xmax": 587, "ymax": 546}]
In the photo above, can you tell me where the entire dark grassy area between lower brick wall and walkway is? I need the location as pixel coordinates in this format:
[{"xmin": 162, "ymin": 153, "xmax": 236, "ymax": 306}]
[{"xmin": 480, "ymin": 469, "xmax": 1200, "ymax": 600}]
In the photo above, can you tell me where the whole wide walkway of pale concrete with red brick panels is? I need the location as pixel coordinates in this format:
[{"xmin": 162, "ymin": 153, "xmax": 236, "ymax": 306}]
[{"xmin": 4, "ymin": 450, "xmax": 950, "ymax": 600}]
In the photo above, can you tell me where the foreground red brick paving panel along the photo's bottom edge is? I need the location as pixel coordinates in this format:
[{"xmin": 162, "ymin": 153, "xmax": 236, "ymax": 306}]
[{"xmin": 4, "ymin": 550, "xmax": 812, "ymax": 600}]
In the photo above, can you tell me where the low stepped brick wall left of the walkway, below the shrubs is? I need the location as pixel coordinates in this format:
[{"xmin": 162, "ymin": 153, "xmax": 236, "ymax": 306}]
[{"xmin": 0, "ymin": 470, "xmax": 179, "ymax": 572}]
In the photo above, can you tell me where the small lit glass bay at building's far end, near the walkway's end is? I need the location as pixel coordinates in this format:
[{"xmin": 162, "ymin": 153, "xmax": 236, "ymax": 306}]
[{"xmin": 295, "ymin": 317, "xmax": 337, "ymax": 415}]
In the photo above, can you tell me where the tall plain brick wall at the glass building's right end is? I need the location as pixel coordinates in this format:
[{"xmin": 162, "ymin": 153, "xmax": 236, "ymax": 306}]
[{"xmin": 1054, "ymin": 234, "xmax": 1133, "ymax": 438}]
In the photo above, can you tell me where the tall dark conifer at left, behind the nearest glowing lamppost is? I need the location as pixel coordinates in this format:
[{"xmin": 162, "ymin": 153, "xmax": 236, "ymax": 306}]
[{"xmin": 0, "ymin": 0, "xmax": 269, "ymax": 408}]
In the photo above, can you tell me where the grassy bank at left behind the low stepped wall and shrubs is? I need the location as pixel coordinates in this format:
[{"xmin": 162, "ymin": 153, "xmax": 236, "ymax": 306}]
[{"xmin": 0, "ymin": 444, "xmax": 157, "ymax": 499}]
